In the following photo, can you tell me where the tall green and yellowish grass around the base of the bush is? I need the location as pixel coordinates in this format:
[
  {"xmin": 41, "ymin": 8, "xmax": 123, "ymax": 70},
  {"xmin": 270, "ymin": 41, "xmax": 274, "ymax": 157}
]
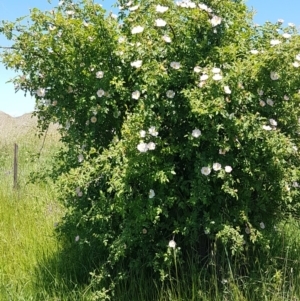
[{"xmin": 0, "ymin": 113, "xmax": 300, "ymax": 301}]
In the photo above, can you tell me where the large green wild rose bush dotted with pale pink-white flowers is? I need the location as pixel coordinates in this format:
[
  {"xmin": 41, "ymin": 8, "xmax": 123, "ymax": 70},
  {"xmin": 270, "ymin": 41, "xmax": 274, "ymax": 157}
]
[{"xmin": 1, "ymin": 0, "xmax": 300, "ymax": 296}]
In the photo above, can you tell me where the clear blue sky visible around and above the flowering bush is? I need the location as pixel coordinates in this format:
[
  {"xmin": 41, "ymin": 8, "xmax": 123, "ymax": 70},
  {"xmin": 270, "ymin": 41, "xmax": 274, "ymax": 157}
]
[{"xmin": 0, "ymin": 0, "xmax": 300, "ymax": 116}]
